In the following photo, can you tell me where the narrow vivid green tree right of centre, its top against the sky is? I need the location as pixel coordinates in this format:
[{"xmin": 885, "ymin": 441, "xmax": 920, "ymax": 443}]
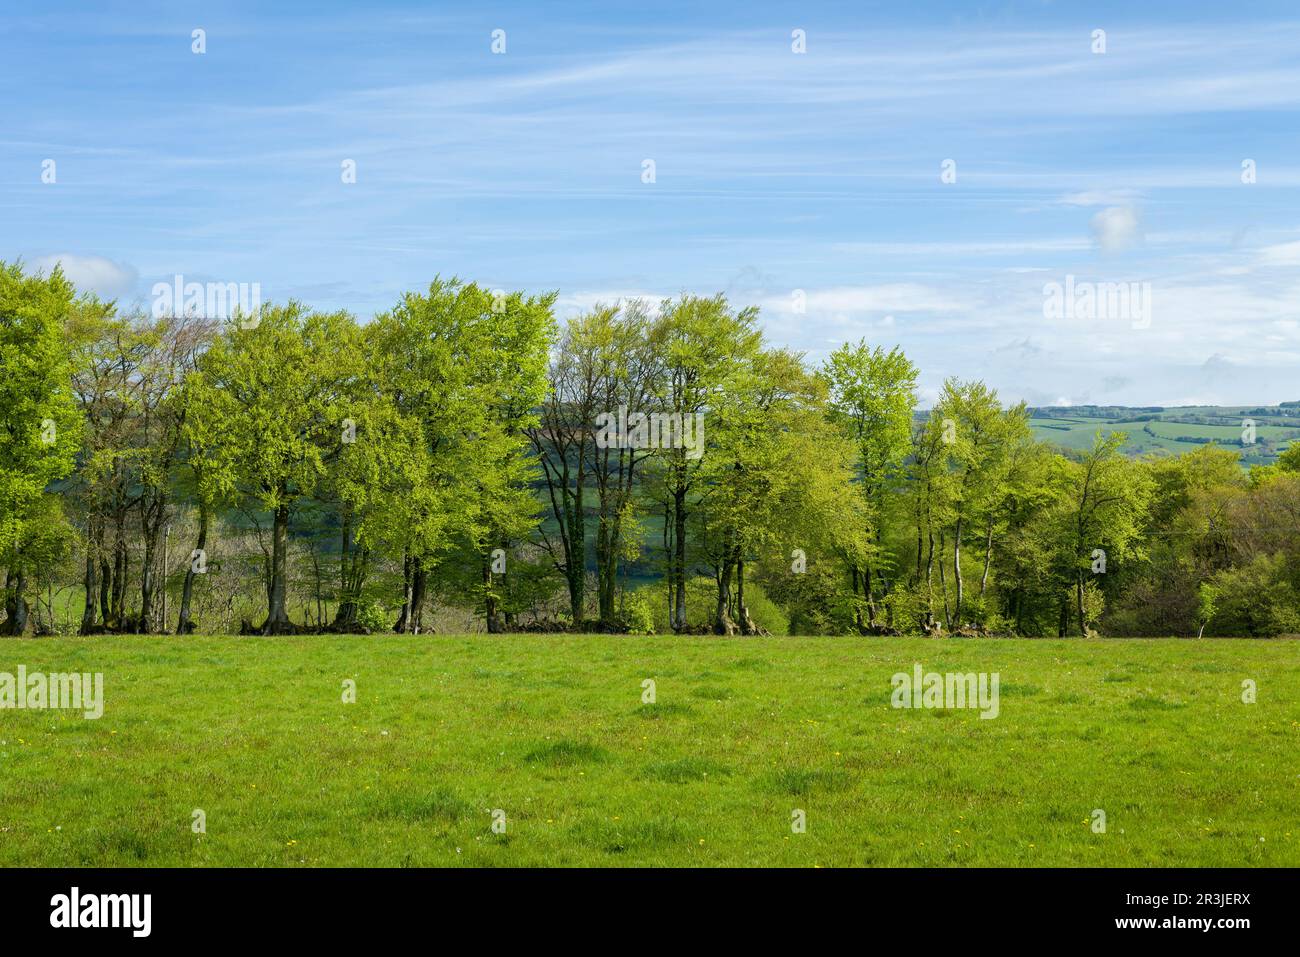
[{"xmin": 822, "ymin": 339, "xmax": 917, "ymax": 629}]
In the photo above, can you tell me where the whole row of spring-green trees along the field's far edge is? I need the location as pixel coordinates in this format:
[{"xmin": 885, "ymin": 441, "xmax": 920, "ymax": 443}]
[{"xmin": 0, "ymin": 264, "xmax": 1300, "ymax": 636}]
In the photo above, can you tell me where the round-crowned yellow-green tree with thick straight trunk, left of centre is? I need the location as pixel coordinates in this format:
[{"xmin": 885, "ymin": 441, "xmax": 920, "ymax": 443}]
[{"xmin": 185, "ymin": 303, "xmax": 361, "ymax": 635}]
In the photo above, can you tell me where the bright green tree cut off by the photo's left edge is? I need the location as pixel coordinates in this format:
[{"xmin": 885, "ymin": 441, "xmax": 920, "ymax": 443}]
[{"xmin": 0, "ymin": 263, "xmax": 81, "ymax": 635}]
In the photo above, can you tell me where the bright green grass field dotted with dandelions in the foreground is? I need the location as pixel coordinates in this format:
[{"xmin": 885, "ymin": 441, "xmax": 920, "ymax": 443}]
[{"xmin": 0, "ymin": 635, "xmax": 1300, "ymax": 867}]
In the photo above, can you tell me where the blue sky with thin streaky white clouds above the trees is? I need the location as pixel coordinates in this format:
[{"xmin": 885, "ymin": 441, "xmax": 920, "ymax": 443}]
[{"xmin": 0, "ymin": 1, "xmax": 1300, "ymax": 404}]
